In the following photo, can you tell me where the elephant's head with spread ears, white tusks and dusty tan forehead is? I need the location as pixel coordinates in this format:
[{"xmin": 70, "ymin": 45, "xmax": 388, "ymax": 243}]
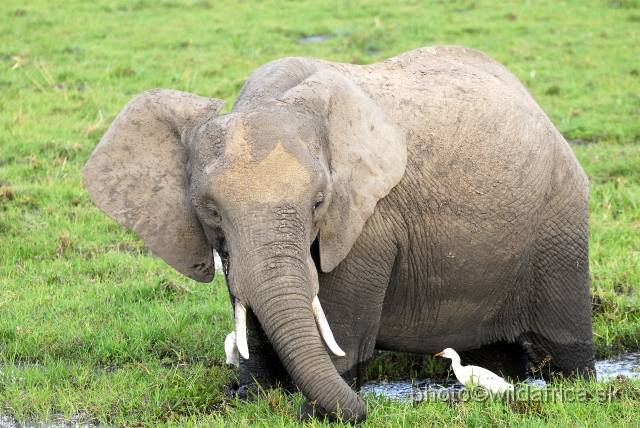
[{"xmin": 83, "ymin": 58, "xmax": 407, "ymax": 419}]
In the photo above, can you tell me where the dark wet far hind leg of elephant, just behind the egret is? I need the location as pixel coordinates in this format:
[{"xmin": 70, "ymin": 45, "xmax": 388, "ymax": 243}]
[{"xmin": 460, "ymin": 342, "xmax": 529, "ymax": 382}]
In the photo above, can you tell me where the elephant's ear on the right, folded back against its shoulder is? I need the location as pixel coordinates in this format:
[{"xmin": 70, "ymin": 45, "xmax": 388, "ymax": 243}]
[{"xmin": 281, "ymin": 71, "xmax": 407, "ymax": 272}]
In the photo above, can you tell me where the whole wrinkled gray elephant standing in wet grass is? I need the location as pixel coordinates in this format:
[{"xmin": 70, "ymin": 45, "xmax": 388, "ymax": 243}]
[{"xmin": 83, "ymin": 47, "xmax": 594, "ymax": 420}]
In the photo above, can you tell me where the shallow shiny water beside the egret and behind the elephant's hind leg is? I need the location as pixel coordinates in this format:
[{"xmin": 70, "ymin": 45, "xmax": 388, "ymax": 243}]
[{"xmin": 362, "ymin": 352, "xmax": 640, "ymax": 400}]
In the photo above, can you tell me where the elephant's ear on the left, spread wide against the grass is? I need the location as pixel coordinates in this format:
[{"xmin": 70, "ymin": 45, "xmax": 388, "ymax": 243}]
[{"xmin": 82, "ymin": 89, "xmax": 224, "ymax": 282}]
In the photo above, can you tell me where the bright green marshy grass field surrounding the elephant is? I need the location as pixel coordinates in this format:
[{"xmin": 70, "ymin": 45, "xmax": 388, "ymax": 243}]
[{"xmin": 0, "ymin": 0, "xmax": 640, "ymax": 427}]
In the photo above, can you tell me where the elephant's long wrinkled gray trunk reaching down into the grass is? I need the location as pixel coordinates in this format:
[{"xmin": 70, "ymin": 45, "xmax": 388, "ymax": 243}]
[{"xmin": 230, "ymin": 227, "xmax": 366, "ymax": 421}]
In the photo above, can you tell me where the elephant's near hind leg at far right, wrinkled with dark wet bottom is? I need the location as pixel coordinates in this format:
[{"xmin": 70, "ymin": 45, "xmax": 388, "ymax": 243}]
[{"xmin": 519, "ymin": 165, "xmax": 595, "ymax": 378}]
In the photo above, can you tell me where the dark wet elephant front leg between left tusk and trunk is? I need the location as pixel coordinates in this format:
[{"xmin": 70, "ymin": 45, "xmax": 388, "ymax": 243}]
[{"xmin": 236, "ymin": 309, "xmax": 294, "ymax": 399}]
